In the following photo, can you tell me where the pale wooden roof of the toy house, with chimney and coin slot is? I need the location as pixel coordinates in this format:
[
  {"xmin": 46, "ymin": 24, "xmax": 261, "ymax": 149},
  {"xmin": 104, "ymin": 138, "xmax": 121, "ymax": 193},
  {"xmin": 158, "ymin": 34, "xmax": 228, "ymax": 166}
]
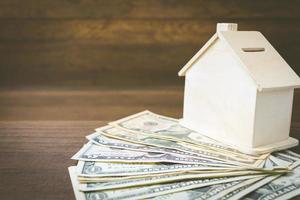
[{"xmin": 178, "ymin": 23, "xmax": 300, "ymax": 91}]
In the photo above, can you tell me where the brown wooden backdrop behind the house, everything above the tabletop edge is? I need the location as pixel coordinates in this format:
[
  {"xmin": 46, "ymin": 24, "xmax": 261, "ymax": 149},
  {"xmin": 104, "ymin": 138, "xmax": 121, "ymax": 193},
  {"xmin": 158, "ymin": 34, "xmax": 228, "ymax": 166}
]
[{"xmin": 0, "ymin": 0, "xmax": 300, "ymax": 120}]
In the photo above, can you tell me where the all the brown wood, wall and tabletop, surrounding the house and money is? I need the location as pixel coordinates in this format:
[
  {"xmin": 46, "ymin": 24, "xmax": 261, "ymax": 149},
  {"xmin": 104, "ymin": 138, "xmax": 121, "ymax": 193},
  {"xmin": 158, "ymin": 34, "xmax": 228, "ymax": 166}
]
[{"xmin": 0, "ymin": 0, "xmax": 300, "ymax": 200}]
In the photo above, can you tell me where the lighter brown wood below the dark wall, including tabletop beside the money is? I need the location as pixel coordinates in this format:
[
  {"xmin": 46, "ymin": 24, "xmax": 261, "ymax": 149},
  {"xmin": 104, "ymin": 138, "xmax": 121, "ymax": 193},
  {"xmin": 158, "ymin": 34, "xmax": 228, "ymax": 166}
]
[{"xmin": 0, "ymin": 90, "xmax": 300, "ymax": 200}]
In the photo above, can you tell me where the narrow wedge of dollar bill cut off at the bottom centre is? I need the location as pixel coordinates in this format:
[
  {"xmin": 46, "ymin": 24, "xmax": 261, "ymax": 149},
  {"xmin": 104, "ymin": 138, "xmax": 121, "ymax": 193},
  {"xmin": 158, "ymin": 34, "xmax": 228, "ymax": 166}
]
[{"xmin": 151, "ymin": 176, "xmax": 264, "ymax": 200}]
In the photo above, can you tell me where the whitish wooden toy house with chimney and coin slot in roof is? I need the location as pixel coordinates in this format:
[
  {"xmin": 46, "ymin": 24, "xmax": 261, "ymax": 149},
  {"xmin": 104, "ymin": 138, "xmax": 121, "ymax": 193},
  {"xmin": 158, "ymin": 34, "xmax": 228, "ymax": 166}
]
[{"xmin": 178, "ymin": 23, "xmax": 300, "ymax": 154}]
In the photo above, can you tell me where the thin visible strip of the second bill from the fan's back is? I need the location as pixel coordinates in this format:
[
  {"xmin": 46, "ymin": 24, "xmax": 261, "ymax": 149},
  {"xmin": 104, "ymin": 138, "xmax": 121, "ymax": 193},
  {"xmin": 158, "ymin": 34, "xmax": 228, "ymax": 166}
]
[{"xmin": 96, "ymin": 126, "xmax": 264, "ymax": 167}]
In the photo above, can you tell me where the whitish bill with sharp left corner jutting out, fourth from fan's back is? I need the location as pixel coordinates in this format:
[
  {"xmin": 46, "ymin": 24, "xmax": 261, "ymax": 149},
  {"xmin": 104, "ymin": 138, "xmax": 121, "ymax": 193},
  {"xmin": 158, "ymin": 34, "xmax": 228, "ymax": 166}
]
[{"xmin": 72, "ymin": 142, "xmax": 234, "ymax": 168}]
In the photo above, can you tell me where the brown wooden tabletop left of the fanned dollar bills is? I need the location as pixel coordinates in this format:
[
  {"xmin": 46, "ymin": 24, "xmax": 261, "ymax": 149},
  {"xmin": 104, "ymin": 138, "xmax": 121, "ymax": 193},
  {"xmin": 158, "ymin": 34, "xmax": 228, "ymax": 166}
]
[{"xmin": 0, "ymin": 121, "xmax": 300, "ymax": 200}]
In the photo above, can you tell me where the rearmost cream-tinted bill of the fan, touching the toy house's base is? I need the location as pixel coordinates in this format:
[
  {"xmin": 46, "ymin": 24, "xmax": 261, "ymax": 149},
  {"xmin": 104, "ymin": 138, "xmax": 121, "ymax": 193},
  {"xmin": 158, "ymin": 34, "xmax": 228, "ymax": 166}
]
[{"xmin": 109, "ymin": 111, "xmax": 268, "ymax": 158}]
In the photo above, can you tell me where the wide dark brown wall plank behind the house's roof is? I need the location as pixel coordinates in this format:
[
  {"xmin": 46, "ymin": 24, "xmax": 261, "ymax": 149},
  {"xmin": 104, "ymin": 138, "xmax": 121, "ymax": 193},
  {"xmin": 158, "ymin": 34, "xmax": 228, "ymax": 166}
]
[{"xmin": 0, "ymin": 20, "xmax": 300, "ymax": 88}]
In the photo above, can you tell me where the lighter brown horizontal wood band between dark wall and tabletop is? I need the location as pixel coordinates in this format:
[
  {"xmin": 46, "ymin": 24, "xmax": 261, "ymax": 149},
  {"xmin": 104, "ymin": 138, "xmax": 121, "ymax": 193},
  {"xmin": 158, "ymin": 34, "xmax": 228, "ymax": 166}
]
[{"xmin": 0, "ymin": 87, "xmax": 300, "ymax": 122}]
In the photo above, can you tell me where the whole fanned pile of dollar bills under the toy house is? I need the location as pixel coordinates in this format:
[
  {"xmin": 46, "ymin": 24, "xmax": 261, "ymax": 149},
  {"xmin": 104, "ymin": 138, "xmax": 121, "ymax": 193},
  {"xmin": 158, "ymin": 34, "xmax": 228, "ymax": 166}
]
[{"xmin": 69, "ymin": 111, "xmax": 300, "ymax": 200}]
